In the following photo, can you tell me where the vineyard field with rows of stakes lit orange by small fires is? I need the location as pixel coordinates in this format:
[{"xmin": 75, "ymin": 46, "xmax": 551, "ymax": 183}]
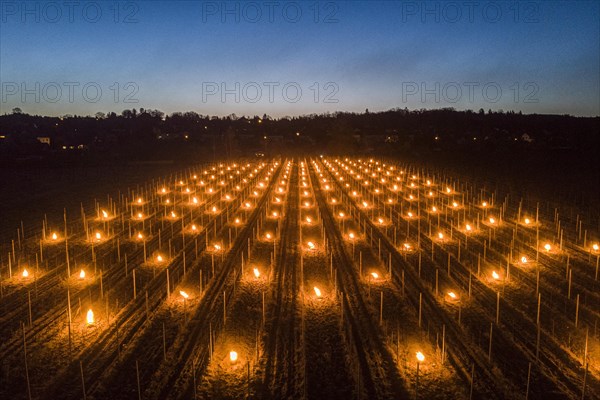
[{"xmin": 0, "ymin": 158, "xmax": 600, "ymax": 399}]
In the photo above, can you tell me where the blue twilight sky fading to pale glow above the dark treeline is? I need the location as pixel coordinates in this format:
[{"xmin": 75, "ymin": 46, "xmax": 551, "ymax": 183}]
[{"xmin": 0, "ymin": 0, "xmax": 600, "ymax": 117}]
